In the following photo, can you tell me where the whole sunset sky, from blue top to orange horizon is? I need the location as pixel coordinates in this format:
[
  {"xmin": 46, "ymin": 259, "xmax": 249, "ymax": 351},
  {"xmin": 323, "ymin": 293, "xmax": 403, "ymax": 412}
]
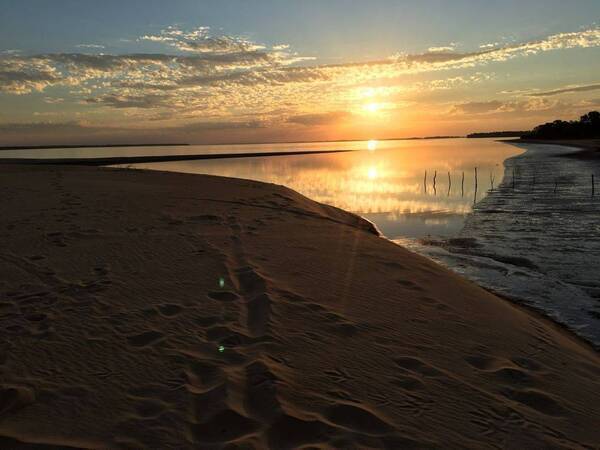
[{"xmin": 0, "ymin": 0, "xmax": 600, "ymax": 146}]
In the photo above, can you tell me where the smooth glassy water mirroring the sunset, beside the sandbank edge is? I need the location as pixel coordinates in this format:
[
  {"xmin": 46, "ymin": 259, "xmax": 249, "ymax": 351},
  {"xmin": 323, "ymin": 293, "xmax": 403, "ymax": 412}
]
[{"xmin": 126, "ymin": 139, "xmax": 522, "ymax": 239}]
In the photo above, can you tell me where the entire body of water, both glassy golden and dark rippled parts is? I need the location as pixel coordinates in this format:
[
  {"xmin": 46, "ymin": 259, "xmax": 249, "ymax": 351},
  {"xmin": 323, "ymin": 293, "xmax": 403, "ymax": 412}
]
[{"xmin": 2, "ymin": 139, "xmax": 600, "ymax": 347}]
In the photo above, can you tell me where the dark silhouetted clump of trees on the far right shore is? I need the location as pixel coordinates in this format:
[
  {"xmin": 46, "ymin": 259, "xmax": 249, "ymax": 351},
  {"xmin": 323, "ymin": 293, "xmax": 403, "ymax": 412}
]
[{"xmin": 522, "ymin": 111, "xmax": 600, "ymax": 139}]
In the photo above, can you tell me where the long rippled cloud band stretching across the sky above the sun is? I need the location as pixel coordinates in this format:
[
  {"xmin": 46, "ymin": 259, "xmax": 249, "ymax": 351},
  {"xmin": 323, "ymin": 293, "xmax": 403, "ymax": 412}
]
[{"xmin": 0, "ymin": 27, "xmax": 600, "ymax": 97}]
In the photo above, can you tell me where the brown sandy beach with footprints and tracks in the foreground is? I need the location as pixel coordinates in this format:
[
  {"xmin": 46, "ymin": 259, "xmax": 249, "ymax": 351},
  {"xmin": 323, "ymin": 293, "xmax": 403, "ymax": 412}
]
[{"xmin": 0, "ymin": 165, "xmax": 600, "ymax": 449}]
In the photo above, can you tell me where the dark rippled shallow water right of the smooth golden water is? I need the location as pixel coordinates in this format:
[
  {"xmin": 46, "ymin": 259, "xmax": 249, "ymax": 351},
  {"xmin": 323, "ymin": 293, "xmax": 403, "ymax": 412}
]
[{"xmin": 399, "ymin": 145, "xmax": 600, "ymax": 348}]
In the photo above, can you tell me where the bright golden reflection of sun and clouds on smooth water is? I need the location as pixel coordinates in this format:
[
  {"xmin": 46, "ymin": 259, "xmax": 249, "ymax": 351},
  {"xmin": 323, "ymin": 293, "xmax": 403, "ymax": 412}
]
[{"xmin": 136, "ymin": 139, "xmax": 521, "ymax": 216}]
